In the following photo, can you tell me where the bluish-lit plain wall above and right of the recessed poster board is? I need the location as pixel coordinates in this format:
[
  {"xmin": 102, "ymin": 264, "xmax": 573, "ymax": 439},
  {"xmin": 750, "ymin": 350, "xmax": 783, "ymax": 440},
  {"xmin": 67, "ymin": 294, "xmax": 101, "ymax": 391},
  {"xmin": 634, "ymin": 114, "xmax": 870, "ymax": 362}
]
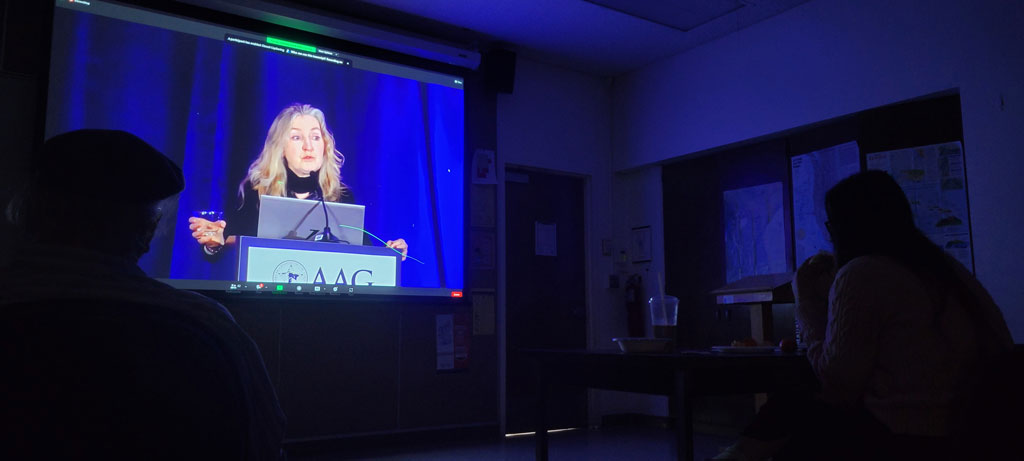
[{"xmin": 612, "ymin": 0, "xmax": 1024, "ymax": 342}]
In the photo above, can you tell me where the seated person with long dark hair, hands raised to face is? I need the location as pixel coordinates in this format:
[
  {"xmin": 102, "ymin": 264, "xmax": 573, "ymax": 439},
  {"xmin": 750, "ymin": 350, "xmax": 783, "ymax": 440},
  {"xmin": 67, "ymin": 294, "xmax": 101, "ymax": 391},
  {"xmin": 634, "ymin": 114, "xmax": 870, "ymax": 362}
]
[{"xmin": 719, "ymin": 170, "xmax": 1013, "ymax": 460}]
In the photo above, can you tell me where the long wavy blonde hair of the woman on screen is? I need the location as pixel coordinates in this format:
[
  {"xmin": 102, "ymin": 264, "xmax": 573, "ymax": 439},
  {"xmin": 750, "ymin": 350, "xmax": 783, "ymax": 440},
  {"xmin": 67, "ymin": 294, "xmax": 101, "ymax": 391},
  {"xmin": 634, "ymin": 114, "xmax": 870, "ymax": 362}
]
[{"xmin": 239, "ymin": 103, "xmax": 348, "ymax": 202}]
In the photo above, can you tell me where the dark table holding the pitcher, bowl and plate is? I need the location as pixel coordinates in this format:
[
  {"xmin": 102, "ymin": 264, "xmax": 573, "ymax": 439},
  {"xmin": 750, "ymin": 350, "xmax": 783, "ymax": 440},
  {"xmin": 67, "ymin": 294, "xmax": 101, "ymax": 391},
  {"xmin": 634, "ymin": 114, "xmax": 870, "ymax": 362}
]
[{"xmin": 520, "ymin": 349, "xmax": 817, "ymax": 461}]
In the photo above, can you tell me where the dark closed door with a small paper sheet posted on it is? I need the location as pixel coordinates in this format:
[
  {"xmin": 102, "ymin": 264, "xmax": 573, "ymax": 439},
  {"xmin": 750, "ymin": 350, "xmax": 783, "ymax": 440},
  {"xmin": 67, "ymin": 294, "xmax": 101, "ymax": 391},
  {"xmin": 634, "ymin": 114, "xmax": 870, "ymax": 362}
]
[{"xmin": 505, "ymin": 169, "xmax": 587, "ymax": 433}]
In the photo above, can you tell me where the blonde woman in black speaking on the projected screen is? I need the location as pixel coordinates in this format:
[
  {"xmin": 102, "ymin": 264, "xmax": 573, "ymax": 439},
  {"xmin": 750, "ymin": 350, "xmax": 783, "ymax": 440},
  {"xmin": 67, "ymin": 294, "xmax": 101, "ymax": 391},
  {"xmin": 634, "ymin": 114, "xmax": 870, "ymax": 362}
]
[{"xmin": 188, "ymin": 103, "xmax": 409, "ymax": 260}]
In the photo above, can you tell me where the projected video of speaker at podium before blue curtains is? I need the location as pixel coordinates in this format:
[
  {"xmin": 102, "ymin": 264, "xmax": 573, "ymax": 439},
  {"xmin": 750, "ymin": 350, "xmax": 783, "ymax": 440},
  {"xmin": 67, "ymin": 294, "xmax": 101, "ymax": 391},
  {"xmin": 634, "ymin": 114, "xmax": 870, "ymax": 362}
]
[{"xmin": 47, "ymin": 2, "xmax": 464, "ymax": 289}]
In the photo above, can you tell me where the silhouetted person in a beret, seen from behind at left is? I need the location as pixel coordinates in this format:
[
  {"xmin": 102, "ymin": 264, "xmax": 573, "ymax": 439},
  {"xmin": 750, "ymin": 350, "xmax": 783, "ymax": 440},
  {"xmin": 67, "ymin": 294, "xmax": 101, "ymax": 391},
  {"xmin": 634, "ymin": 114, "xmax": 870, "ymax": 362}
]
[{"xmin": 0, "ymin": 130, "xmax": 285, "ymax": 460}]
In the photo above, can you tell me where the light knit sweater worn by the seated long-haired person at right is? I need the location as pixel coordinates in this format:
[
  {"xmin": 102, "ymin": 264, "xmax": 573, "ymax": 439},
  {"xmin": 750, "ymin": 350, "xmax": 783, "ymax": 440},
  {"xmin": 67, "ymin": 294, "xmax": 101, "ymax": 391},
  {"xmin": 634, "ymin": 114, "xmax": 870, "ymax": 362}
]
[{"xmin": 798, "ymin": 255, "xmax": 1013, "ymax": 436}]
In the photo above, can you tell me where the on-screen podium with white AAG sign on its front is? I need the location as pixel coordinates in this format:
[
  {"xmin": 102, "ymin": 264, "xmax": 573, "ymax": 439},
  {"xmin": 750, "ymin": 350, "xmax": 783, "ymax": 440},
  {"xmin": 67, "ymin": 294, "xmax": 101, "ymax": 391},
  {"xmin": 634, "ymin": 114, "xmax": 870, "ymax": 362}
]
[{"xmin": 237, "ymin": 236, "xmax": 401, "ymax": 287}]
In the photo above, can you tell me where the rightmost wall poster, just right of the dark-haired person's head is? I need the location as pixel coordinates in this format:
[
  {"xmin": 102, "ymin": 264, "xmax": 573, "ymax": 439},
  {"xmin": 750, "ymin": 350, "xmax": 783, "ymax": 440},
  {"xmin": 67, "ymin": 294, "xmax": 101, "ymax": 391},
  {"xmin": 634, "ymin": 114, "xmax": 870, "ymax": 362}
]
[{"xmin": 867, "ymin": 141, "xmax": 974, "ymax": 271}]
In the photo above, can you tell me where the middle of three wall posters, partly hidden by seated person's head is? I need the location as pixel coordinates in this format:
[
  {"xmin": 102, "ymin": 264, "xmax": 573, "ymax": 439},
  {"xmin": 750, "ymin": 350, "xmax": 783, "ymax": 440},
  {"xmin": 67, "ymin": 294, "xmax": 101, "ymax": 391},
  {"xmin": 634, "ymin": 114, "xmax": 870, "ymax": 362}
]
[{"xmin": 790, "ymin": 141, "xmax": 860, "ymax": 266}]
